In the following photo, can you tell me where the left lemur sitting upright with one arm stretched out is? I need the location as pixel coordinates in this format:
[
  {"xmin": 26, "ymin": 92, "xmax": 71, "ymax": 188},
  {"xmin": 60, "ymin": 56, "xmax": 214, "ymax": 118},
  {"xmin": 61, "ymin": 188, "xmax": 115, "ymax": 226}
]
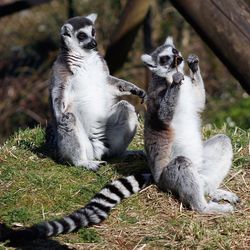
[{"xmin": 46, "ymin": 14, "xmax": 145, "ymax": 170}]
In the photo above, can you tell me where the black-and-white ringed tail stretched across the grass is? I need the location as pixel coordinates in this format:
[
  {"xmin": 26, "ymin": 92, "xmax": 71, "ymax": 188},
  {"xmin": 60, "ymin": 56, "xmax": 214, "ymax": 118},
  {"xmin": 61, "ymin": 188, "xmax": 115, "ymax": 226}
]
[{"xmin": 0, "ymin": 174, "xmax": 152, "ymax": 242}]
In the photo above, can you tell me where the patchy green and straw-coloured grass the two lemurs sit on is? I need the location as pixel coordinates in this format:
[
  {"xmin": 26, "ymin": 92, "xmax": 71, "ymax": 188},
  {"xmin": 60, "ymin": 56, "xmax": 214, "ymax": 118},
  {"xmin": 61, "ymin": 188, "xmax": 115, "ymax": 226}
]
[{"xmin": 0, "ymin": 126, "xmax": 250, "ymax": 249}]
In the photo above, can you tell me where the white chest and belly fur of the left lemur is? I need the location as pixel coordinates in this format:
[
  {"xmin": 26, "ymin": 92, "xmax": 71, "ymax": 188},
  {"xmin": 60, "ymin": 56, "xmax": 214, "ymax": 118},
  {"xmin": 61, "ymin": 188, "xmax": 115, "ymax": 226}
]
[{"xmin": 65, "ymin": 54, "xmax": 113, "ymax": 131}]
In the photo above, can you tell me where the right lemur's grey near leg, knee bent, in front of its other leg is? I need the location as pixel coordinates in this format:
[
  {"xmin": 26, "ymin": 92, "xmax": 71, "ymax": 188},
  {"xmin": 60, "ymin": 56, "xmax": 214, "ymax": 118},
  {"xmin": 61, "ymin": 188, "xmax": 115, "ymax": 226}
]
[{"xmin": 158, "ymin": 156, "xmax": 233, "ymax": 213}]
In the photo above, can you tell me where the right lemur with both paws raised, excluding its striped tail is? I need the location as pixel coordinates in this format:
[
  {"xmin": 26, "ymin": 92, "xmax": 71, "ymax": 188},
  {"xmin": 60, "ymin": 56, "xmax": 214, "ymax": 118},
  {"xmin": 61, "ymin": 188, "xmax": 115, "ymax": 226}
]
[{"xmin": 142, "ymin": 37, "xmax": 238, "ymax": 213}]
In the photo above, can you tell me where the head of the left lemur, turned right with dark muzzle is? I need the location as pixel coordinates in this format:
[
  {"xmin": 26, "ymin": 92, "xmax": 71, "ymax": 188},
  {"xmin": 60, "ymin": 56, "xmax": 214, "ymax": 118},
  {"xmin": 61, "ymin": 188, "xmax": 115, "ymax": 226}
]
[{"xmin": 61, "ymin": 13, "xmax": 97, "ymax": 50}]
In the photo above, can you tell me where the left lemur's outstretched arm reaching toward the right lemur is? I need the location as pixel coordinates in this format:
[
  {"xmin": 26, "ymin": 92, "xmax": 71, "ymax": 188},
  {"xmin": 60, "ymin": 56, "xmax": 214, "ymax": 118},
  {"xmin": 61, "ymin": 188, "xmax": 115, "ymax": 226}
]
[{"xmin": 108, "ymin": 75, "xmax": 146, "ymax": 99}]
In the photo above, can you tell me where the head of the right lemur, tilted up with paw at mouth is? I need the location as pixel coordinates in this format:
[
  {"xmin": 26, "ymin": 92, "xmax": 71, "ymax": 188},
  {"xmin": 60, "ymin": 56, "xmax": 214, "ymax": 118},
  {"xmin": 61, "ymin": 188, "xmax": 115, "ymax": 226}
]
[{"xmin": 141, "ymin": 37, "xmax": 183, "ymax": 77}]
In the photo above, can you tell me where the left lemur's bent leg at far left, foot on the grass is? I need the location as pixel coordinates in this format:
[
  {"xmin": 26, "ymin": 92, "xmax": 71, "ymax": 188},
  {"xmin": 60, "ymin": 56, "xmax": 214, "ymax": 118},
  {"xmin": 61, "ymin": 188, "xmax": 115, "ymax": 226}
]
[{"xmin": 57, "ymin": 112, "xmax": 104, "ymax": 170}]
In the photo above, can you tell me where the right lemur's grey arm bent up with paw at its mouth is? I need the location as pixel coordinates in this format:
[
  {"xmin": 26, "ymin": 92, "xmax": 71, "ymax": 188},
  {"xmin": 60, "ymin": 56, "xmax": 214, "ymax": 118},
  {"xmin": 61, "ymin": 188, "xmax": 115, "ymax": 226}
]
[{"xmin": 158, "ymin": 72, "xmax": 184, "ymax": 123}]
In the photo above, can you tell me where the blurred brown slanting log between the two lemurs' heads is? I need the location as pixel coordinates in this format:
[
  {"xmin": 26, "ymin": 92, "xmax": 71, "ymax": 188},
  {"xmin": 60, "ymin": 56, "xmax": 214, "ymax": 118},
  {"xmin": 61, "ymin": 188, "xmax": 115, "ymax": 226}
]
[{"xmin": 105, "ymin": 0, "xmax": 150, "ymax": 73}]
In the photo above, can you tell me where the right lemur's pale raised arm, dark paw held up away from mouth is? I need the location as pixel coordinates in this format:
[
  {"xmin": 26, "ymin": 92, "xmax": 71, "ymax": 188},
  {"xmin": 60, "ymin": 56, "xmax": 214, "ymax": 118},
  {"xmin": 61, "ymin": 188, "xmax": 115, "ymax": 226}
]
[{"xmin": 187, "ymin": 55, "xmax": 206, "ymax": 111}]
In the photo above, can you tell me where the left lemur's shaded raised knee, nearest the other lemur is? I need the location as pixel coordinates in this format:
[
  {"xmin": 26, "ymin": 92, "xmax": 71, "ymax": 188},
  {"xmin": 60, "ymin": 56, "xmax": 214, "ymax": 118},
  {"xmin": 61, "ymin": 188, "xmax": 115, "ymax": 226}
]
[{"xmin": 106, "ymin": 101, "xmax": 138, "ymax": 156}]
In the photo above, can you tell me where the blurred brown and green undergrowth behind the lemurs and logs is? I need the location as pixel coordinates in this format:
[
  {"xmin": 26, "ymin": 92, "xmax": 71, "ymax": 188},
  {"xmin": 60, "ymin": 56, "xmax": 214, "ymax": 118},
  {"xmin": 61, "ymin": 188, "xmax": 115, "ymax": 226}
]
[{"xmin": 0, "ymin": 0, "xmax": 250, "ymax": 143}]
